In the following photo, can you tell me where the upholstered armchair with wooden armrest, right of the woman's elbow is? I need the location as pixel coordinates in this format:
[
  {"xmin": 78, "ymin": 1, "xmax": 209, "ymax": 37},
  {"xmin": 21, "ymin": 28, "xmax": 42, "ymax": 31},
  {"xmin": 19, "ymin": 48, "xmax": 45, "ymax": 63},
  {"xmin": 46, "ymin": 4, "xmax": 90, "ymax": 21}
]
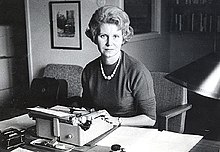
[{"xmin": 151, "ymin": 72, "xmax": 192, "ymax": 133}]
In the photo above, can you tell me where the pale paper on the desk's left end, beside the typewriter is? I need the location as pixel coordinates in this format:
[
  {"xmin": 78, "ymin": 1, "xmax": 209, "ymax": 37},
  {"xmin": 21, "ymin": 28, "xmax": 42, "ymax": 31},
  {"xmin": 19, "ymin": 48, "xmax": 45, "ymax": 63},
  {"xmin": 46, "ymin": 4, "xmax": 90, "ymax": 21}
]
[{"xmin": 0, "ymin": 114, "xmax": 35, "ymax": 130}]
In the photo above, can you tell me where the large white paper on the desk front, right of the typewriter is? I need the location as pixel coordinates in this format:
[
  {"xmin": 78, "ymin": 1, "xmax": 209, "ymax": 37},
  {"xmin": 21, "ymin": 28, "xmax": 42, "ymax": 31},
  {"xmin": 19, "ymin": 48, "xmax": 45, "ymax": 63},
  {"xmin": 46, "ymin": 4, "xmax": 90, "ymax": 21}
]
[{"xmin": 97, "ymin": 127, "xmax": 202, "ymax": 152}]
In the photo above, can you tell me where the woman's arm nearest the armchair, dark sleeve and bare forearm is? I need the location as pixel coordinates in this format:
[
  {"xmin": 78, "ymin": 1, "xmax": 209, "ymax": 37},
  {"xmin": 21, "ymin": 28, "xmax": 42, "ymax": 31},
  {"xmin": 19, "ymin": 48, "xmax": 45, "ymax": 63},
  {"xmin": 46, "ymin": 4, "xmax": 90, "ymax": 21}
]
[{"xmin": 128, "ymin": 64, "xmax": 156, "ymax": 126}]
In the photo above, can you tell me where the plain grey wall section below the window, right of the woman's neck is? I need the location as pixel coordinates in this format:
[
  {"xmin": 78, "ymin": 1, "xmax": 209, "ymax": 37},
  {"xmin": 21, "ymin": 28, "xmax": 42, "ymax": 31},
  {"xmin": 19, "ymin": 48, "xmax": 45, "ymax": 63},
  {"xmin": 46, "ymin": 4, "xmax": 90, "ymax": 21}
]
[{"xmin": 123, "ymin": 35, "xmax": 169, "ymax": 72}]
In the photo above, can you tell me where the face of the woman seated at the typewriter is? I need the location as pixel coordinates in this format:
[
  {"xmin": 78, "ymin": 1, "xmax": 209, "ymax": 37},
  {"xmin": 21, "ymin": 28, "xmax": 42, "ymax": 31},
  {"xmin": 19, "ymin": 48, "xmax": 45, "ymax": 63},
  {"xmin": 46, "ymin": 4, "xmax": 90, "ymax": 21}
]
[{"xmin": 97, "ymin": 23, "xmax": 123, "ymax": 58}]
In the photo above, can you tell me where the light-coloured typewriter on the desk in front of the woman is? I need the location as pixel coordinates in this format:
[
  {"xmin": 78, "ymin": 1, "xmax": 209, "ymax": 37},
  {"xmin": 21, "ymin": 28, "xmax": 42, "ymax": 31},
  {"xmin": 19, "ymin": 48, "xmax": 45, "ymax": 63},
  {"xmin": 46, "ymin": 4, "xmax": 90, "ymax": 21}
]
[{"xmin": 28, "ymin": 105, "xmax": 115, "ymax": 146}]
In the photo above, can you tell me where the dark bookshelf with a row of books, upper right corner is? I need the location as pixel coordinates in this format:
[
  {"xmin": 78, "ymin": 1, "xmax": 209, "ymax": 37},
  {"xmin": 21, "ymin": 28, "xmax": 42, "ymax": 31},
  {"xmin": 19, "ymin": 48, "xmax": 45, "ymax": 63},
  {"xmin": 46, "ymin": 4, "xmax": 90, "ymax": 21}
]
[{"xmin": 170, "ymin": 0, "xmax": 220, "ymax": 33}]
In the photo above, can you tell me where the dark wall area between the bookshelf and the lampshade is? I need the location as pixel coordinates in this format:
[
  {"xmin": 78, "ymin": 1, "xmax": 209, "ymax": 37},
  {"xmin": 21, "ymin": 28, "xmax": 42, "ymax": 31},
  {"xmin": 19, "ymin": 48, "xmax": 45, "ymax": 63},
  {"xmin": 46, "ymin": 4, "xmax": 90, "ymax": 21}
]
[{"xmin": 170, "ymin": 33, "xmax": 217, "ymax": 71}]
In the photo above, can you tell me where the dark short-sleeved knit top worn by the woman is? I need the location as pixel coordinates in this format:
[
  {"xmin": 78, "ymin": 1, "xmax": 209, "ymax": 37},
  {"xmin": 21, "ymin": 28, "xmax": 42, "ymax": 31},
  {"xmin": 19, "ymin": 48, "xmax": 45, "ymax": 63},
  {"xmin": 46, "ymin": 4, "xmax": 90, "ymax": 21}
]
[{"xmin": 82, "ymin": 51, "xmax": 156, "ymax": 120}]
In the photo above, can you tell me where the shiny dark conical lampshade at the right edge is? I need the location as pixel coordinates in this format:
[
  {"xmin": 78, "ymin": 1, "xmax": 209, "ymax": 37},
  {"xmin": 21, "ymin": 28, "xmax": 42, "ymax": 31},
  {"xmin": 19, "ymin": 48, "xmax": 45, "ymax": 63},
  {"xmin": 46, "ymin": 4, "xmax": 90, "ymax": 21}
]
[{"xmin": 165, "ymin": 52, "xmax": 220, "ymax": 100}]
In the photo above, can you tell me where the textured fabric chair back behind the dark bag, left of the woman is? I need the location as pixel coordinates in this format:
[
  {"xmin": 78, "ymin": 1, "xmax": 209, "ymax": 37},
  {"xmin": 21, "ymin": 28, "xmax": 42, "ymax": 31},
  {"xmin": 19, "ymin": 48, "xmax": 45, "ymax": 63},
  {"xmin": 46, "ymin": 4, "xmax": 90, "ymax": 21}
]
[{"xmin": 43, "ymin": 64, "xmax": 83, "ymax": 98}]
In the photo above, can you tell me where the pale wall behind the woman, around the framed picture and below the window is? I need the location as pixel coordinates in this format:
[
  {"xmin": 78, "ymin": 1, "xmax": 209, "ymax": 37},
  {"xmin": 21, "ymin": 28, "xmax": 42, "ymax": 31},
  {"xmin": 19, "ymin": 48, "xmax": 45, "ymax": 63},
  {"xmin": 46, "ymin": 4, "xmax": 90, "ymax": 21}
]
[{"xmin": 26, "ymin": 0, "xmax": 169, "ymax": 80}]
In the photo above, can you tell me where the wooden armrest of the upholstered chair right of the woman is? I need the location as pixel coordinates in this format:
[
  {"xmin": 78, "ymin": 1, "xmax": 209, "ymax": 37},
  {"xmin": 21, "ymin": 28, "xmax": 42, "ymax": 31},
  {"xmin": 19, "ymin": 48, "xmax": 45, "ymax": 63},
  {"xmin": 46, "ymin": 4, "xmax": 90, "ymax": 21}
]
[{"xmin": 158, "ymin": 104, "xmax": 192, "ymax": 131}]
